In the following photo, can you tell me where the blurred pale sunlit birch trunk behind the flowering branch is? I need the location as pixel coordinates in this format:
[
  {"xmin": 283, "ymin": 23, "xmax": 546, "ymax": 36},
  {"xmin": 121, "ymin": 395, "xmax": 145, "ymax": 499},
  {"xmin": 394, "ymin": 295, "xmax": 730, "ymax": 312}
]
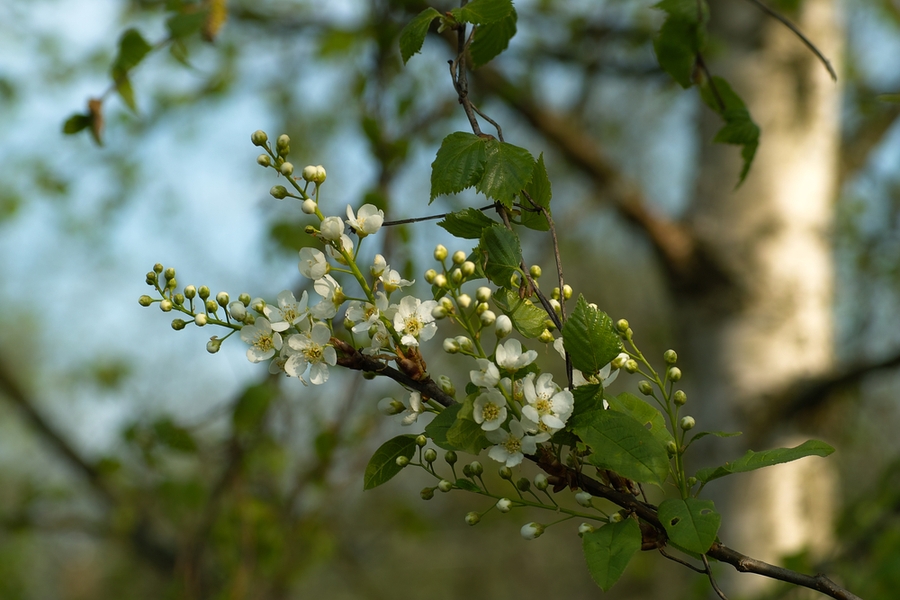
[{"xmin": 677, "ymin": 0, "xmax": 843, "ymax": 591}]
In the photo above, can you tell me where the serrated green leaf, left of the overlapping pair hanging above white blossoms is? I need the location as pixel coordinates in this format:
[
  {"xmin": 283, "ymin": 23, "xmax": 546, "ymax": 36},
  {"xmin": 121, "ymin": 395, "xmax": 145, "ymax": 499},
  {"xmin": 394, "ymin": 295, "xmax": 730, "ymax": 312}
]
[{"xmin": 429, "ymin": 131, "xmax": 487, "ymax": 204}]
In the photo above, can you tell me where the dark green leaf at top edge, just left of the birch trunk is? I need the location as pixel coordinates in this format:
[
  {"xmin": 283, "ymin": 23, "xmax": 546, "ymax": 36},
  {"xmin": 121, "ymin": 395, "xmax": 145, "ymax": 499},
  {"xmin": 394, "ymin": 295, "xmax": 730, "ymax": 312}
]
[{"xmin": 653, "ymin": 0, "xmax": 709, "ymax": 88}]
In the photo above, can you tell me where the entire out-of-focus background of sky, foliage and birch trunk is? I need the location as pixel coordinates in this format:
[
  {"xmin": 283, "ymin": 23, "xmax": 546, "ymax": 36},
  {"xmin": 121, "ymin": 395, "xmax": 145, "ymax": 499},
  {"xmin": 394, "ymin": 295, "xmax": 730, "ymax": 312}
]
[{"xmin": 0, "ymin": 0, "xmax": 900, "ymax": 600}]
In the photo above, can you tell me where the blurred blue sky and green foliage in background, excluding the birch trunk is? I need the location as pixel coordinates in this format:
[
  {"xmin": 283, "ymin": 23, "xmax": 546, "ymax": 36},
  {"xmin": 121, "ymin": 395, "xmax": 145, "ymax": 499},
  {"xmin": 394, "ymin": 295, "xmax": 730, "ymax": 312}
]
[{"xmin": 0, "ymin": 0, "xmax": 900, "ymax": 600}]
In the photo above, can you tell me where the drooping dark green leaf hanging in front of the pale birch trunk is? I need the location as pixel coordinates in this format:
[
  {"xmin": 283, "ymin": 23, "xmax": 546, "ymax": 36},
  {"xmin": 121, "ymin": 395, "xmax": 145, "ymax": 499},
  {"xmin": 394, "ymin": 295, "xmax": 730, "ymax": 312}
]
[{"xmin": 700, "ymin": 77, "xmax": 760, "ymax": 187}]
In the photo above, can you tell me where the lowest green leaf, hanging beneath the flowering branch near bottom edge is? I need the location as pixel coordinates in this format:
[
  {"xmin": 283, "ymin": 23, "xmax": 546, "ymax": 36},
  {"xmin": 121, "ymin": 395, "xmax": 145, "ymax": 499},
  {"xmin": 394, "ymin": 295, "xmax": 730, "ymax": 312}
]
[{"xmin": 581, "ymin": 519, "xmax": 641, "ymax": 592}]
